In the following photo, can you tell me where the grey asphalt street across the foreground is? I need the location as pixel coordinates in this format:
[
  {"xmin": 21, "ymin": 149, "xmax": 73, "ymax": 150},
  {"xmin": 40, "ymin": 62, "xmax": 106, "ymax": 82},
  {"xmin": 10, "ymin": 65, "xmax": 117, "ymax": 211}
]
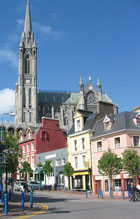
[{"xmin": 18, "ymin": 191, "xmax": 140, "ymax": 219}]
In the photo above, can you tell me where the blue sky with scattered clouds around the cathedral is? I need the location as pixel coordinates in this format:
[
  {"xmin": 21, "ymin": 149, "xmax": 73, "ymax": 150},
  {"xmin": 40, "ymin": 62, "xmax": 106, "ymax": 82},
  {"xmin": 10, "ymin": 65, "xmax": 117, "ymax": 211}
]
[{"xmin": 0, "ymin": 0, "xmax": 140, "ymax": 120}]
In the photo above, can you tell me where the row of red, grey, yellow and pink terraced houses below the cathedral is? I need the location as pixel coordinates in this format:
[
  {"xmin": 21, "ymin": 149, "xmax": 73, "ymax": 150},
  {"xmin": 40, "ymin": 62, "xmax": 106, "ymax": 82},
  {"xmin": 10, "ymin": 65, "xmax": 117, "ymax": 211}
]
[{"xmin": 18, "ymin": 102, "xmax": 140, "ymax": 197}]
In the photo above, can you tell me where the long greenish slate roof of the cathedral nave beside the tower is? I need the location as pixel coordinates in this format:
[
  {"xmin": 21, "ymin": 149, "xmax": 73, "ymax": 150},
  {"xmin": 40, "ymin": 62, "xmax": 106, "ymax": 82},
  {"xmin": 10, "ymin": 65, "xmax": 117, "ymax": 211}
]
[{"xmin": 38, "ymin": 91, "xmax": 78, "ymax": 104}]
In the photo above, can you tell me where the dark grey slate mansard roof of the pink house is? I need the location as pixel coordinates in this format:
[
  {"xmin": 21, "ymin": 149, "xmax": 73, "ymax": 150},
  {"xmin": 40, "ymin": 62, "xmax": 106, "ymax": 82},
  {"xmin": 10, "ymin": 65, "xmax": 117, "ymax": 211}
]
[{"xmin": 91, "ymin": 112, "xmax": 140, "ymax": 138}]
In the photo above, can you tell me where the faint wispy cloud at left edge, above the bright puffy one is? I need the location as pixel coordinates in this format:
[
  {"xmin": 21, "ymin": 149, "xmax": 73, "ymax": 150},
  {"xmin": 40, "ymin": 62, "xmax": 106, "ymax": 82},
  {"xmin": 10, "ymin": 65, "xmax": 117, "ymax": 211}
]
[{"xmin": 0, "ymin": 48, "xmax": 18, "ymax": 68}]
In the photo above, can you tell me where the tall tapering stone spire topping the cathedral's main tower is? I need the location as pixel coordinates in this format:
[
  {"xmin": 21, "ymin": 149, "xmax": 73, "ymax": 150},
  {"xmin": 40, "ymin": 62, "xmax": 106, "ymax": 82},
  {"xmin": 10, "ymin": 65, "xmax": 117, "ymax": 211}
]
[{"xmin": 24, "ymin": 0, "xmax": 32, "ymax": 32}]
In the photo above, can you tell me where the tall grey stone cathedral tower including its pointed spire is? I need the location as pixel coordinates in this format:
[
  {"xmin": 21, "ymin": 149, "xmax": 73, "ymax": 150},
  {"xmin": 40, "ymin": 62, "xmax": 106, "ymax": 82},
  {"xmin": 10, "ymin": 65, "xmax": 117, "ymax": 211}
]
[{"xmin": 15, "ymin": 0, "xmax": 37, "ymax": 126}]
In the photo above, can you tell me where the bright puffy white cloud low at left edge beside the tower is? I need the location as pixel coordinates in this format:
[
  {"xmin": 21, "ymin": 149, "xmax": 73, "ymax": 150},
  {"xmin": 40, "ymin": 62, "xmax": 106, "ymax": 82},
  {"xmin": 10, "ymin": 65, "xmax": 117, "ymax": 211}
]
[{"xmin": 0, "ymin": 88, "xmax": 15, "ymax": 115}]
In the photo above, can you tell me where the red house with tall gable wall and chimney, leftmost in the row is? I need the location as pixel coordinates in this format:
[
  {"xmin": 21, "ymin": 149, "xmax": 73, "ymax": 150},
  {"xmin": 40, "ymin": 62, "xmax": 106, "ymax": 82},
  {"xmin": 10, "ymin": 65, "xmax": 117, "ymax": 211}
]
[{"xmin": 19, "ymin": 117, "xmax": 67, "ymax": 179}]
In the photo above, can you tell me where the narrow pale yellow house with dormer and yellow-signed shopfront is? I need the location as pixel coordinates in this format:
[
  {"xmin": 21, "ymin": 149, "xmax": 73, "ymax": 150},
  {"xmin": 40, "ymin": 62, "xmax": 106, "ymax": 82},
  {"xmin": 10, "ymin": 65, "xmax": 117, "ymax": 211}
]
[{"xmin": 67, "ymin": 110, "xmax": 92, "ymax": 190}]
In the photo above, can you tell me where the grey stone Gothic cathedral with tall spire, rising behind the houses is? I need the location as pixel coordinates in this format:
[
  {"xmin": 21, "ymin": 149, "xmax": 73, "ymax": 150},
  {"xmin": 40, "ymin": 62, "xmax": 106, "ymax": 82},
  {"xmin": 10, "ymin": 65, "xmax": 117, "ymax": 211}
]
[{"xmin": 15, "ymin": 0, "xmax": 117, "ymax": 132}]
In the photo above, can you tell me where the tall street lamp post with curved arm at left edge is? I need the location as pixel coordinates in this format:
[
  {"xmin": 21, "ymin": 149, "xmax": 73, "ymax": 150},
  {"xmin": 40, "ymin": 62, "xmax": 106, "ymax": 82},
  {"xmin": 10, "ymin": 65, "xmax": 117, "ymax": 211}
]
[{"xmin": 0, "ymin": 112, "xmax": 15, "ymax": 203}]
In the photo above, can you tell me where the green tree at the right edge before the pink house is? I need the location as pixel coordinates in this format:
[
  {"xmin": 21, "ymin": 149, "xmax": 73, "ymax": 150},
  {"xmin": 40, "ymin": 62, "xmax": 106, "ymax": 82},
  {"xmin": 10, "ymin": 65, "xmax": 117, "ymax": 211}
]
[{"xmin": 123, "ymin": 148, "xmax": 140, "ymax": 183}]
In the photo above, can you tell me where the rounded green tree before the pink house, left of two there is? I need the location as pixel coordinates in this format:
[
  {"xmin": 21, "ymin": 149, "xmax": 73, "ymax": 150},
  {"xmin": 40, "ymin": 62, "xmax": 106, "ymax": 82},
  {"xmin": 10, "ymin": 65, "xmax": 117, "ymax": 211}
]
[{"xmin": 98, "ymin": 149, "xmax": 123, "ymax": 184}]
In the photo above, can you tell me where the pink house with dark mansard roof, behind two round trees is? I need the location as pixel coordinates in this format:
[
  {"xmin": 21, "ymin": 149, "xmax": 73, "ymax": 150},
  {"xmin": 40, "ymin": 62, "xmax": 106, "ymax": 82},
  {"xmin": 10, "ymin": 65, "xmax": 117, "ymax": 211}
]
[{"xmin": 91, "ymin": 112, "xmax": 140, "ymax": 195}]
